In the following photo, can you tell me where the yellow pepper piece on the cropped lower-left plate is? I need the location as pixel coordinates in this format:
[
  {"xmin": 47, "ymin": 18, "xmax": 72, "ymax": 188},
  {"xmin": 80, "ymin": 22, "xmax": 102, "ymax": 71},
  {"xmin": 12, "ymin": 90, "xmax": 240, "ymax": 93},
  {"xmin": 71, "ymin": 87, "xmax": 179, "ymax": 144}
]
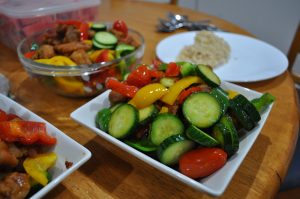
[{"xmin": 23, "ymin": 152, "xmax": 57, "ymax": 186}]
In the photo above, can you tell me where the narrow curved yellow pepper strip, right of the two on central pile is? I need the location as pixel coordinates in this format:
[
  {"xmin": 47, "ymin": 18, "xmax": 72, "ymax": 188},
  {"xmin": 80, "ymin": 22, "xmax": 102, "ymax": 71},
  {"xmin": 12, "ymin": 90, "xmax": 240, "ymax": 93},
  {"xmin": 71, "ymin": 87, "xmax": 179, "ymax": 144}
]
[{"xmin": 160, "ymin": 76, "xmax": 202, "ymax": 105}]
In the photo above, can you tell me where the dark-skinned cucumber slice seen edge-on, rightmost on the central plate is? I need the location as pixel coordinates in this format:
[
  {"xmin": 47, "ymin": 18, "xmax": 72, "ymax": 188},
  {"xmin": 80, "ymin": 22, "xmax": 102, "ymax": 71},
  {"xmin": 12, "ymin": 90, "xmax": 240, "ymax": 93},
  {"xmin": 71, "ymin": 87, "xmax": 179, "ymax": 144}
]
[{"xmin": 232, "ymin": 94, "xmax": 261, "ymax": 124}]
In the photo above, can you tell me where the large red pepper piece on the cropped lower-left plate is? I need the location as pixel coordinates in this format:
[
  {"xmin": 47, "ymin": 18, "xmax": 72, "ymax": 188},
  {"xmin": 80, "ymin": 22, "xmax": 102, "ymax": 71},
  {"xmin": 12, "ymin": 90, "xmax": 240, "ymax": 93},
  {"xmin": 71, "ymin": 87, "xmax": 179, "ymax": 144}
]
[{"xmin": 0, "ymin": 121, "xmax": 56, "ymax": 145}]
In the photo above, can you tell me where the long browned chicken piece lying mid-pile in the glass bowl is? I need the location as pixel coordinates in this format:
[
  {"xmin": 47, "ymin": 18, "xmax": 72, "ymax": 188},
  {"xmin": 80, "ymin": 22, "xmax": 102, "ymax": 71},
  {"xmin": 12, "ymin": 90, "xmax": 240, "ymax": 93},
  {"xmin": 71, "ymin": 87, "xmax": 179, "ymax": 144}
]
[{"xmin": 54, "ymin": 42, "xmax": 92, "ymax": 54}]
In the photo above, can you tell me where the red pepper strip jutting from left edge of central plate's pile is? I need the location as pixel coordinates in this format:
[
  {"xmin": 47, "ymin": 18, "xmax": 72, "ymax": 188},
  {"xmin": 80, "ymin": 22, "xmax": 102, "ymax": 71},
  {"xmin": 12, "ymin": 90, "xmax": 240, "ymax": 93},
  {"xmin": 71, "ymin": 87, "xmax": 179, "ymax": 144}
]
[{"xmin": 105, "ymin": 78, "xmax": 138, "ymax": 98}]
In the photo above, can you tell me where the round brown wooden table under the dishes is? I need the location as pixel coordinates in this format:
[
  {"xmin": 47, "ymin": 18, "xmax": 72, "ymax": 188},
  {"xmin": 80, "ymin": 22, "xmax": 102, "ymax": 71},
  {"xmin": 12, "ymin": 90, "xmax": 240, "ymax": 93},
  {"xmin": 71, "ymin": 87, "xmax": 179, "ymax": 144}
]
[{"xmin": 0, "ymin": 0, "xmax": 298, "ymax": 199}]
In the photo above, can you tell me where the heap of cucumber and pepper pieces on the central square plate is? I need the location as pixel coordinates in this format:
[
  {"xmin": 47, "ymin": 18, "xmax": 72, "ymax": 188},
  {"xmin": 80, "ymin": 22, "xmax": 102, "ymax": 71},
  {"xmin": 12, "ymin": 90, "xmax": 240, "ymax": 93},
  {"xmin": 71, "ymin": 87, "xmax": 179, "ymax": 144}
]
[{"xmin": 95, "ymin": 62, "xmax": 274, "ymax": 179}]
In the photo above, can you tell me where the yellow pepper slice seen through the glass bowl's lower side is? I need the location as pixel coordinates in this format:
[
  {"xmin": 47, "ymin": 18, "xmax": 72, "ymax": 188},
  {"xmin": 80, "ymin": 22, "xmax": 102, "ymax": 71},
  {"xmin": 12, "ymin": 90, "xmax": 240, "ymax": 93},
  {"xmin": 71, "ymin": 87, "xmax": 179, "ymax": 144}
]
[{"xmin": 54, "ymin": 77, "xmax": 84, "ymax": 94}]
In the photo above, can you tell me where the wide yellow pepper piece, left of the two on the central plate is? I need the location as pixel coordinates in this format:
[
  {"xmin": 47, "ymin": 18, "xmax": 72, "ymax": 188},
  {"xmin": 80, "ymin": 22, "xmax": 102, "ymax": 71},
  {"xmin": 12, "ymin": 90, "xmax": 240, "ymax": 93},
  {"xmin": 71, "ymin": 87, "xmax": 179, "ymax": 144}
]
[{"xmin": 128, "ymin": 83, "xmax": 168, "ymax": 109}]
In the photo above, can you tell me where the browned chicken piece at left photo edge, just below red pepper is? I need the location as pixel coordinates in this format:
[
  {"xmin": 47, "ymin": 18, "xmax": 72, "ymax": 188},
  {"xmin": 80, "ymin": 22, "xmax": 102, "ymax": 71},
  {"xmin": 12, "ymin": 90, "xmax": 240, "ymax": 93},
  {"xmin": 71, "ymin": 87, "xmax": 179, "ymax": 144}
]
[{"xmin": 0, "ymin": 140, "xmax": 19, "ymax": 167}]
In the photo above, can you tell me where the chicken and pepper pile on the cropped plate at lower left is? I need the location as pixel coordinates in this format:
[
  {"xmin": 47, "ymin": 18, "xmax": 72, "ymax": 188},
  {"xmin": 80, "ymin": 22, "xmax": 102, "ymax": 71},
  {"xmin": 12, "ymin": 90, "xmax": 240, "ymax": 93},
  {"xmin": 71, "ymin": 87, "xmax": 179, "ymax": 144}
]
[{"xmin": 0, "ymin": 110, "xmax": 57, "ymax": 198}]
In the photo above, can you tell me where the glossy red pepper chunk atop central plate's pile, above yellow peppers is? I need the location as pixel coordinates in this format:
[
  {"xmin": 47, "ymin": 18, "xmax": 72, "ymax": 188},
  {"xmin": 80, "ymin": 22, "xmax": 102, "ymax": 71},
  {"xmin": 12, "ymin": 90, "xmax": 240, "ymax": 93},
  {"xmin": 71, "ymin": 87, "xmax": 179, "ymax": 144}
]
[{"xmin": 126, "ymin": 65, "xmax": 151, "ymax": 88}]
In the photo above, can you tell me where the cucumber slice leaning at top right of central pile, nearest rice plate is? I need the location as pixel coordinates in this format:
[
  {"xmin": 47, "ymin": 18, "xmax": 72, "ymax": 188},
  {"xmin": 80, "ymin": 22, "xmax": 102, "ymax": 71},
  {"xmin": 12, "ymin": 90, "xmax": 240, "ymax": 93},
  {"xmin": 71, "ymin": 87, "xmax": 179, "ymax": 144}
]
[{"xmin": 196, "ymin": 64, "xmax": 221, "ymax": 87}]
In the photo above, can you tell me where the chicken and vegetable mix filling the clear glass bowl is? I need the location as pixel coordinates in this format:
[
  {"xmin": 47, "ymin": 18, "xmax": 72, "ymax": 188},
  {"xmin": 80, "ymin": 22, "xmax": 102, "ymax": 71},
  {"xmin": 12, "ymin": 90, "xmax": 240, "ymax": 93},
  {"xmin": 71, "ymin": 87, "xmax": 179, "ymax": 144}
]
[{"xmin": 24, "ymin": 20, "xmax": 141, "ymax": 95}]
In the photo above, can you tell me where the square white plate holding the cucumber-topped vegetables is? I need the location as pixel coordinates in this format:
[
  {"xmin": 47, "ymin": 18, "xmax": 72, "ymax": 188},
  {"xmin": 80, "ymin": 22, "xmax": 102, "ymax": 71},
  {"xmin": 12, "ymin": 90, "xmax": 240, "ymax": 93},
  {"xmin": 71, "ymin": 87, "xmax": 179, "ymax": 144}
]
[{"xmin": 71, "ymin": 82, "xmax": 272, "ymax": 196}]
